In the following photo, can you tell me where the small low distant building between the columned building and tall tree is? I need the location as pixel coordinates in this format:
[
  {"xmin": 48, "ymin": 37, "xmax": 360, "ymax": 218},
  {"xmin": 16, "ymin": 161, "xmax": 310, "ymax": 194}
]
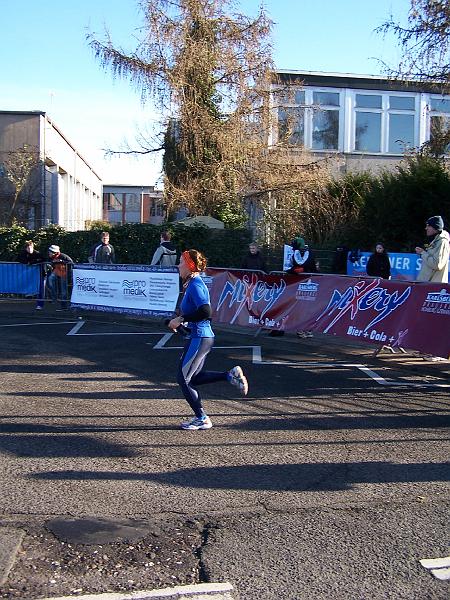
[{"xmin": 103, "ymin": 184, "xmax": 167, "ymax": 225}]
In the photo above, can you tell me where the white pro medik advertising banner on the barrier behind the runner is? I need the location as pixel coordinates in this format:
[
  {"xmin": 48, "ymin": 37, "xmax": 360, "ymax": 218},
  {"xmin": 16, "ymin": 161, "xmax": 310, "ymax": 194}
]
[{"xmin": 71, "ymin": 264, "xmax": 179, "ymax": 316}]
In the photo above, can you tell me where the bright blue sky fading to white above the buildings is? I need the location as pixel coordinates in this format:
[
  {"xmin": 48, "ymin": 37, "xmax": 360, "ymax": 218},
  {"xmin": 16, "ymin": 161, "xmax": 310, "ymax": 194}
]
[{"xmin": 0, "ymin": 0, "xmax": 410, "ymax": 185}]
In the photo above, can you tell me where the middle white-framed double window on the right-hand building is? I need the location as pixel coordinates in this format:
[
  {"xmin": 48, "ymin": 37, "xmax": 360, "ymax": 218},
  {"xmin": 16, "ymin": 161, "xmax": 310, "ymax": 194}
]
[{"xmin": 354, "ymin": 93, "xmax": 415, "ymax": 154}]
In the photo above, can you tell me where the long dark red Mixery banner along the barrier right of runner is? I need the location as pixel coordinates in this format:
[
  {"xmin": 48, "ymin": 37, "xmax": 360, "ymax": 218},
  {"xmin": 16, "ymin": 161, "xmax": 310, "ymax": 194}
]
[{"xmin": 205, "ymin": 269, "xmax": 450, "ymax": 358}]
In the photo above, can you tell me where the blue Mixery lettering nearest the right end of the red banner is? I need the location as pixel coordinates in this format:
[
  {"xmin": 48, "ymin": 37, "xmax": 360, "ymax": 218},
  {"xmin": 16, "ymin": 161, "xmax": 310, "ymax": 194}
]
[{"xmin": 316, "ymin": 279, "xmax": 412, "ymax": 335}]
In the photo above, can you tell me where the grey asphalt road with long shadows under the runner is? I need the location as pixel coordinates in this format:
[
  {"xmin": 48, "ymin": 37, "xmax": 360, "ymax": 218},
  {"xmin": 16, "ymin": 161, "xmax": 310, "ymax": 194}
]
[{"xmin": 0, "ymin": 307, "xmax": 450, "ymax": 600}]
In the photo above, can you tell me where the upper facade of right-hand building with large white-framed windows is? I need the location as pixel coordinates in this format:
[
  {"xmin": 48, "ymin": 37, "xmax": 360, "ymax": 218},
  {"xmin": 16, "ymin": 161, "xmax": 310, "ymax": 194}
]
[{"xmin": 269, "ymin": 70, "xmax": 450, "ymax": 172}]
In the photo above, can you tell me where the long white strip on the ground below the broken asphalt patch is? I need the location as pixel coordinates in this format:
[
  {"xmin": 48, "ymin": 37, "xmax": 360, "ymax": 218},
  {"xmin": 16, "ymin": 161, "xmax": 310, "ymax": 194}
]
[{"xmin": 42, "ymin": 583, "xmax": 233, "ymax": 600}]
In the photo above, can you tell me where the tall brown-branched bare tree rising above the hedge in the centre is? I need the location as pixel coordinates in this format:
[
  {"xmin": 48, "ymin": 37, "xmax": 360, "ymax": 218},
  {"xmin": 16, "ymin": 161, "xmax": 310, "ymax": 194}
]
[{"xmin": 89, "ymin": 0, "xmax": 334, "ymax": 240}]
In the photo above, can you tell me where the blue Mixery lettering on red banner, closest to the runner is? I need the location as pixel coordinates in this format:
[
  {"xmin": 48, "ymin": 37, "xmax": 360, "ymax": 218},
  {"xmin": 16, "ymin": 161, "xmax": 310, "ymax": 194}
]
[{"xmin": 217, "ymin": 273, "xmax": 286, "ymax": 323}]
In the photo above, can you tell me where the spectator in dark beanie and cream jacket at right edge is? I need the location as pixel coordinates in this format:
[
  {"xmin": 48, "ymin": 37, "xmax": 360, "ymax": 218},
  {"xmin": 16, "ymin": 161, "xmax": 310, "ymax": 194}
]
[{"xmin": 416, "ymin": 215, "xmax": 450, "ymax": 283}]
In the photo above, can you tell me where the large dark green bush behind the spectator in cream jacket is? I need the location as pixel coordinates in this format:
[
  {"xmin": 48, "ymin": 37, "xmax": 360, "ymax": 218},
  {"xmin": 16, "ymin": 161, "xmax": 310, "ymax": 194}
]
[{"xmin": 329, "ymin": 153, "xmax": 450, "ymax": 252}]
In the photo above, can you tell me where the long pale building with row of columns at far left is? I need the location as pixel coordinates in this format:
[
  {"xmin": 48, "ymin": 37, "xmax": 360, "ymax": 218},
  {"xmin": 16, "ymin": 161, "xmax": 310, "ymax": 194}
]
[{"xmin": 0, "ymin": 111, "xmax": 102, "ymax": 231}]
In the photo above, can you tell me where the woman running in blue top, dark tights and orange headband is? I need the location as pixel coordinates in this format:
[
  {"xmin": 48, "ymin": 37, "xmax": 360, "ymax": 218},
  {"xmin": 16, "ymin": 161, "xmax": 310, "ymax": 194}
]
[{"xmin": 168, "ymin": 250, "xmax": 248, "ymax": 430}]
